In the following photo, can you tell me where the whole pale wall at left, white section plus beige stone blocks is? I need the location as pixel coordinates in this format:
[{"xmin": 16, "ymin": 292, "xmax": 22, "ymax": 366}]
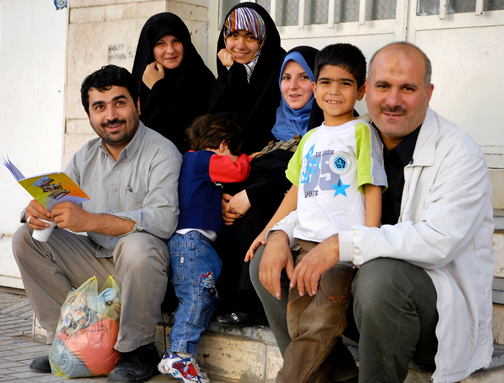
[{"xmin": 0, "ymin": 0, "xmax": 208, "ymax": 288}]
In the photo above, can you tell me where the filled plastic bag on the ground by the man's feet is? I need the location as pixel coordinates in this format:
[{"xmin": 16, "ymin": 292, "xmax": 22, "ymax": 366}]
[{"xmin": 49, "ymin": 276, "xmax": 121, "ymax": 378}]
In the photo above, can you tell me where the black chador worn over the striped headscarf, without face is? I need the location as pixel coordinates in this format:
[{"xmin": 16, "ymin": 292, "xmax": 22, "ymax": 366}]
[{"xmin": 208, "ymin": 3, "xmax": 285, "ymax": 153}]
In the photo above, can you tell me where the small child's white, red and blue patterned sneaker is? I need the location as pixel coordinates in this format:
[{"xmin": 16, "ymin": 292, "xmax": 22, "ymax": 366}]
[{"xmin": 158, "ymin": 352, "xmax": 210, "ymax": 383}]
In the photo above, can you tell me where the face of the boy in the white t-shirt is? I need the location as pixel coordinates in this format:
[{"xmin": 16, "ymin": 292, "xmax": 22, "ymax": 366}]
[{"xmin": 312, "ymin": 65, "xmax": 365, "ymax": 126}]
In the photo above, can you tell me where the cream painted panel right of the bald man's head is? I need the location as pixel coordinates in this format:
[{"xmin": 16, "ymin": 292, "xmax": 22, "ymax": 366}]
[{"xmin": 416, "ymin": 26, "xmax": 504, "ymax": 152}]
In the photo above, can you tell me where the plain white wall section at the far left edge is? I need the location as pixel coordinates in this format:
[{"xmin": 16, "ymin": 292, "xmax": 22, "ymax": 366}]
[{"xmin": 0, "ymin": 0, "xmax": 68, "ymax": 287}]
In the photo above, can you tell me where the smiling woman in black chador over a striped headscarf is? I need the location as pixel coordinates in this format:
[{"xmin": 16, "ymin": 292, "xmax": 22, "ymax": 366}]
[{"xmin": 208, "ymin": 3, "xmax": 285, "ymax": 153}]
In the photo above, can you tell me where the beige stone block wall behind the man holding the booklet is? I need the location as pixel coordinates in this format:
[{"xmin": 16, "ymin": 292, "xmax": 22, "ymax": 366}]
[{"xmin": 63, "ymin": 0, "xmax": 208, "ymax": 164}]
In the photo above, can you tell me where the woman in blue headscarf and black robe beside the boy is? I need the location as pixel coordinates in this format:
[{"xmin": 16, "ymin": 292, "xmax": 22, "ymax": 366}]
[{"xmin": 216, "ymin": 46, "xmax": 323, "ymax": 325}]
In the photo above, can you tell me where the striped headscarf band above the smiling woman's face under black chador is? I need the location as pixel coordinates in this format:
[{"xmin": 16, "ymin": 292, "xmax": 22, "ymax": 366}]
[{"xmin": 223, "ymin": 7, "xmax": 266, "ymax": 51}]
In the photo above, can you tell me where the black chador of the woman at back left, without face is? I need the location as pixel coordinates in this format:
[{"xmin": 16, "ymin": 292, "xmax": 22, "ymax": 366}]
[{"xmin": 133, "ymin": 12, "xmax": 215, "ymax": 153}]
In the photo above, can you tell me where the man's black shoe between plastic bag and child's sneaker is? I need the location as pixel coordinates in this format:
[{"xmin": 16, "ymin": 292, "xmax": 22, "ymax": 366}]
[{"xmin": 108, "ymin": 343, "xmax": 160, "ymax": 383}]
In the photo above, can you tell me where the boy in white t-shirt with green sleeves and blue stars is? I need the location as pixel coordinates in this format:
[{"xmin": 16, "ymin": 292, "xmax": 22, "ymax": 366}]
[{"xmin": 272, "ymin": 44, "xmax": 387, "ymax": 383}]
